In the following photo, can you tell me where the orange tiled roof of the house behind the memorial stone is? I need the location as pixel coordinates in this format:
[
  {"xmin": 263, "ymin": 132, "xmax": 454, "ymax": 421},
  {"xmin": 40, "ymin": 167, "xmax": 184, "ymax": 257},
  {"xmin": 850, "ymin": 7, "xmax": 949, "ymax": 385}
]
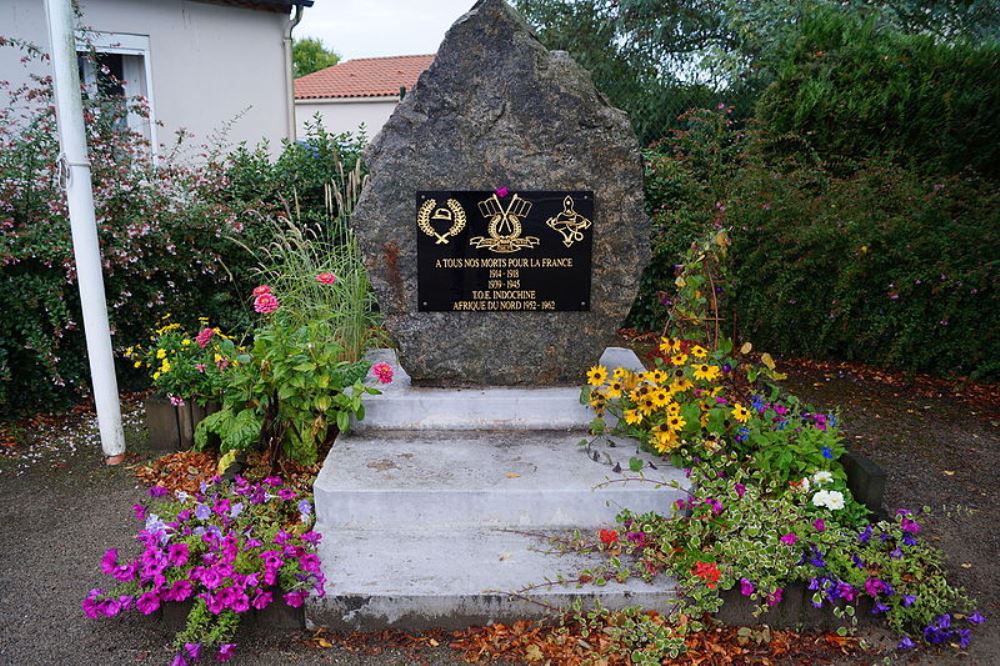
[{"xmin": 295, "ymin": 54, "xmax": 434, "ymax": 99}]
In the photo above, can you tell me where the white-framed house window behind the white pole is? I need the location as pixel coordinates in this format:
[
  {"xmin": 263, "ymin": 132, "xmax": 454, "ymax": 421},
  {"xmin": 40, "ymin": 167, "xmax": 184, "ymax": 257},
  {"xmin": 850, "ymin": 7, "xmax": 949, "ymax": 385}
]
[{"xmin": 76, "ymin": 32, "xmax": 157, "ymax": 153}]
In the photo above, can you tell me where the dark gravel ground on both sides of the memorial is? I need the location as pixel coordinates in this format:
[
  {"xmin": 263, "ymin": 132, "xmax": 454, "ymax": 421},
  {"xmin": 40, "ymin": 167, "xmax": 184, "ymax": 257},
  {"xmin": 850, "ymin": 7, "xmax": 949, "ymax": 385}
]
[{"xmin": 0, "ymin": 370, "xmax": 1000, "ymax": 666}]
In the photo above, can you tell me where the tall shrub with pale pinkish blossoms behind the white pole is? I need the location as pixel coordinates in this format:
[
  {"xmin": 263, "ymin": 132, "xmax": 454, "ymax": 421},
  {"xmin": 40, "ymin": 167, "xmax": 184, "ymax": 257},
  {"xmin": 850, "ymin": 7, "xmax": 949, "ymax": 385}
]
[{"xmin": 0, "ymin": 39, "xmax": 363, "ymax": 414}]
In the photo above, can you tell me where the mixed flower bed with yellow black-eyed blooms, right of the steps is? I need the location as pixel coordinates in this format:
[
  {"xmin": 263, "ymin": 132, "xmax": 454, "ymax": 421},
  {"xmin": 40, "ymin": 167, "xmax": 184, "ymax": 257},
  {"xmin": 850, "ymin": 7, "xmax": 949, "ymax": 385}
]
[{"xmin": 583, "ymin": 227, "xmax": 984, "ymax": 664}]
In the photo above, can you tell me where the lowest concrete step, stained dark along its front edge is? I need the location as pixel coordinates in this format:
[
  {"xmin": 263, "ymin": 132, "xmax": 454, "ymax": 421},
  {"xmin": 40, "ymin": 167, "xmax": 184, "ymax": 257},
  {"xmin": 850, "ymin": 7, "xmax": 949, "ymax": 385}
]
[{"xmin": 307, "ymin": 524, "xmax": 676, "ymax": 631}]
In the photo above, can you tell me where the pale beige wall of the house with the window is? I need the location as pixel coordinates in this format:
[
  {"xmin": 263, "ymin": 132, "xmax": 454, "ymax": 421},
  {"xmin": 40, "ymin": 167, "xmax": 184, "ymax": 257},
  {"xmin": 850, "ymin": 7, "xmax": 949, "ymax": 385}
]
[{"xmin": 0, "ymin": 0, "xmax": 289, "ymax": 154}]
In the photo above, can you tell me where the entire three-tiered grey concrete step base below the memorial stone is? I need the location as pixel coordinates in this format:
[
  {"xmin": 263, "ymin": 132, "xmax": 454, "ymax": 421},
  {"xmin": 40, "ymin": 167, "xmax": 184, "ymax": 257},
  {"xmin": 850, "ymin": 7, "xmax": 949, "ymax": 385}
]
[{"xmin": 307, "ymin": 349, "xmax": 686, "ymax": 631}]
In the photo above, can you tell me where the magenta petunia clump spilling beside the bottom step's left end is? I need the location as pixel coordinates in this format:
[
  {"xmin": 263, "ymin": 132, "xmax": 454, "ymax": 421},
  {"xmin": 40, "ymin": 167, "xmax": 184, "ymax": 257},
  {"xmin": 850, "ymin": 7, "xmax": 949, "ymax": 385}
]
[{"xmin": 82, "ymin": 476, "xmax": 325, "ymax": 666}]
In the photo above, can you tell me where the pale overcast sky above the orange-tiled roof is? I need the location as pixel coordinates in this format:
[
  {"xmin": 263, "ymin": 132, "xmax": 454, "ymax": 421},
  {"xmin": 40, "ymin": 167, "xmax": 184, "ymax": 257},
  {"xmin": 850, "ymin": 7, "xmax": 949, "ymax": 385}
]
[{"xmin": 294, "ymin": 0, "xmax": 475, "ymax": 60}]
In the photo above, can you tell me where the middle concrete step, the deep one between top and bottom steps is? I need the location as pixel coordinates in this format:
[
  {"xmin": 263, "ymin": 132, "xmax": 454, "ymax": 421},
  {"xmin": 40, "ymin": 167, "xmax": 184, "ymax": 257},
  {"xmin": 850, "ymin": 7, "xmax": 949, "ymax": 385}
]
[{"xmin": 314, "ymin": 431, "xmax": 687, "ymax": 532}]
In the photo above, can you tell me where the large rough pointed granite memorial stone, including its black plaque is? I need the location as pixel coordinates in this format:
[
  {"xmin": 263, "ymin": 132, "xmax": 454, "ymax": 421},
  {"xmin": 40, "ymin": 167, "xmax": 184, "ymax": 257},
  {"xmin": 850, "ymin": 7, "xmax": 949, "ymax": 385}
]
[{"xmin": 353, "ymin": 0, "xmax": 649, "ymax": 386}]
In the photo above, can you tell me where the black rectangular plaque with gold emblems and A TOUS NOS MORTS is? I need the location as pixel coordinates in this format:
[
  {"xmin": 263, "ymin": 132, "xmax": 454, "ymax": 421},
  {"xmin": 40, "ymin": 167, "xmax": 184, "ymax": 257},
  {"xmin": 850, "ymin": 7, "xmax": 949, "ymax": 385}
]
[{"xmin": 416, "ymin": 190, "xmax": 595, "ymax": 312}]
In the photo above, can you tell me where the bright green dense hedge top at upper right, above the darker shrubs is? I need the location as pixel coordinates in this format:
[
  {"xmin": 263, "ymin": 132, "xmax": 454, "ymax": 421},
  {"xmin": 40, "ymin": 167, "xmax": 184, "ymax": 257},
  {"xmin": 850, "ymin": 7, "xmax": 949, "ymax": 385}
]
[{"xmin": 757, "ymin": 9, "xmax": 1000, "ymax": 178}]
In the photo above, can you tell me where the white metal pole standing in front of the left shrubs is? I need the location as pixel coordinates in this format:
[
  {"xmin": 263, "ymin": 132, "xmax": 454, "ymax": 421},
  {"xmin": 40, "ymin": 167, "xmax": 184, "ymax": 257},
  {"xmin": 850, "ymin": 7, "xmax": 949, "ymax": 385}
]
[{"xmin": 45, "ymin": 0, "xmax": 125, "ymax": 464}]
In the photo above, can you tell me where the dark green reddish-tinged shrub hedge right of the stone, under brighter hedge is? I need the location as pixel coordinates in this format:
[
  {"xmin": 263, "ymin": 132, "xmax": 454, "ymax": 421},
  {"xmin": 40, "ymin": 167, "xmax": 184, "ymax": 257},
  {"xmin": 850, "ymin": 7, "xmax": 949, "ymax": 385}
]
[{"xmin": 630, "ymin": 111, "xmax": 1000, "ymax": 379}]
